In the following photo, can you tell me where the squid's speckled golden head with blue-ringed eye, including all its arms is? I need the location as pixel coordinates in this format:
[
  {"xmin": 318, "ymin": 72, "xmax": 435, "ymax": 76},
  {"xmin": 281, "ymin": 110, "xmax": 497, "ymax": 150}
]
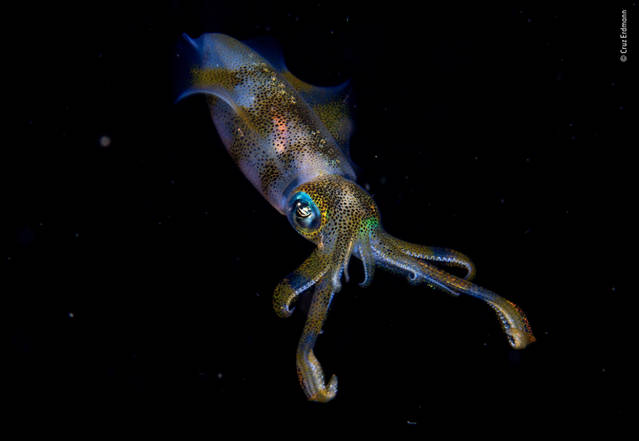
[{"xmin": 273, "ymin": 175, "xmax": 535, "ymax": 402}]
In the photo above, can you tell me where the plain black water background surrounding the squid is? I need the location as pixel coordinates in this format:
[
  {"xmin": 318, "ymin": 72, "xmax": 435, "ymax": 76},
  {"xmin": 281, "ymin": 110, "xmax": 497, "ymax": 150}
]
[{"xmin": 2, "ymin": 1, "xmax": 639, "ymax": 433}]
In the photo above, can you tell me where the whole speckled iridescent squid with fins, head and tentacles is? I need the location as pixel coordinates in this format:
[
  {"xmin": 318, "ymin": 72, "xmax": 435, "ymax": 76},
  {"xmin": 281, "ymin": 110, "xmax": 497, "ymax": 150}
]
[{"xmin": 176, "ymin": 33, "xmax": 535, "ymax": 402}]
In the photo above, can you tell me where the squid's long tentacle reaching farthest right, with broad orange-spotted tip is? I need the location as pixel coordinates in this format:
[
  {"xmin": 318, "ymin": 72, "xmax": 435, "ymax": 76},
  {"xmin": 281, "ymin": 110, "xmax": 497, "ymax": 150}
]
[{"xmin": 372, "ymin": 233, "xmax": 535, "ymax": 349}]
